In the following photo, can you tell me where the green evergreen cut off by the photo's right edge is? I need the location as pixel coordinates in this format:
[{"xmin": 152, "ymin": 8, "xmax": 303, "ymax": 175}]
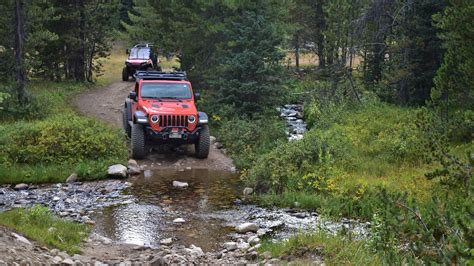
[{"xmin": 431, "ymin": 1, "xmax": 474, "ymax": 131}]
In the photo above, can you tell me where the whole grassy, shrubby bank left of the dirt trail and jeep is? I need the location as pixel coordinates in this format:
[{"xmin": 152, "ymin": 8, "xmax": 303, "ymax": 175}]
[{"xmin": 0, "ymin": 81, "xmax": 127, "ymax": 183}]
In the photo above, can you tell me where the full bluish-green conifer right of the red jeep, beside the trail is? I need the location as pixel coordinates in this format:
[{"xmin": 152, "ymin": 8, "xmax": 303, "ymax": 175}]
[{"xmin": 213, "ymin": 4, "xmax": 283, "ymax": 114}]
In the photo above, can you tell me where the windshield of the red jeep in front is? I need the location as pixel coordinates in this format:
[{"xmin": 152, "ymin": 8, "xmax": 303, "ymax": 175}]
[{"xmin": 140, "ymin": 83, "xmax": 192, "ymax": 100}]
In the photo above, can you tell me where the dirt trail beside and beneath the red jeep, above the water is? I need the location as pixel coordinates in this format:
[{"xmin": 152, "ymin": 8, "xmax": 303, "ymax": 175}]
[{"xmin": 74, "ymin": 82, "xmax": 234, "ymax": 171}]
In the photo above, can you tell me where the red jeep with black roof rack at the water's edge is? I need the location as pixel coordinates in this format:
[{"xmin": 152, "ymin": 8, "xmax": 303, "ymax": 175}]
[{"xmin": 123, "ymin": 71, "xmax": 210, "ymax": 159}]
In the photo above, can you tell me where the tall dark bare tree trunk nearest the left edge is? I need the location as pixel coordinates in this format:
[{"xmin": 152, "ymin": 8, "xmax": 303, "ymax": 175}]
[{"xmin": 15, "ymin": 0, "xmax": 29, "ymax": 105}]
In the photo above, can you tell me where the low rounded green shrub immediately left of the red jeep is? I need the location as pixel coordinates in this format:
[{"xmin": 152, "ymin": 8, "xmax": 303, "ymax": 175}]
[{"xmin": 0, "ymin": 114, "xmax": 127, "ymax": 164}]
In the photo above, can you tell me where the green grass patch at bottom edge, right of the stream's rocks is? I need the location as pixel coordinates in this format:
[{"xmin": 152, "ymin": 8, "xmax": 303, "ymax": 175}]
[{"xmin": 258, "ymin": 232, "xmax": 382, "ymax": 265}]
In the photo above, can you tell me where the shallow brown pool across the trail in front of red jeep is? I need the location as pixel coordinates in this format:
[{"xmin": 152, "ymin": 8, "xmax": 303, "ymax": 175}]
[{"xmin": 94, "ymin": 169, "xmax": 242, "ymax": 250}]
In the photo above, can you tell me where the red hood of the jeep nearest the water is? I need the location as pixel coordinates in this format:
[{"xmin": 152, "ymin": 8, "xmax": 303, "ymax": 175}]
[{"xmin": 142, "ymin": 100, "xmax": 197, "ymax": 115}]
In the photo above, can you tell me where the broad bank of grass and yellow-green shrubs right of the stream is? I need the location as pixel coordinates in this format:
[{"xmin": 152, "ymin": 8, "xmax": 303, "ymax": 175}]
[{"xmin": 214, "ymin": 91, "xmax": 474, "ymax": 264}]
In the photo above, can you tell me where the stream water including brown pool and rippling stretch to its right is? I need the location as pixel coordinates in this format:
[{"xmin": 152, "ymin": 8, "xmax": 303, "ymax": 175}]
[{"xmin": 93, "ymin": 169, "xmax": 366, "ymax": 251}]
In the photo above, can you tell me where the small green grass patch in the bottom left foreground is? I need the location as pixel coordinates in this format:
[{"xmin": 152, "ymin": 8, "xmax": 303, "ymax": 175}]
[{"xmin": 0, "ymin": 206, "xmax": 89, "ymax": 254}]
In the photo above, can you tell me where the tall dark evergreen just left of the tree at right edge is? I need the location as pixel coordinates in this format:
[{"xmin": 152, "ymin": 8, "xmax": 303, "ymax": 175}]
[{"xmin": 382, "ymin": 0, "xmax": 444, "ymax": 105}]
